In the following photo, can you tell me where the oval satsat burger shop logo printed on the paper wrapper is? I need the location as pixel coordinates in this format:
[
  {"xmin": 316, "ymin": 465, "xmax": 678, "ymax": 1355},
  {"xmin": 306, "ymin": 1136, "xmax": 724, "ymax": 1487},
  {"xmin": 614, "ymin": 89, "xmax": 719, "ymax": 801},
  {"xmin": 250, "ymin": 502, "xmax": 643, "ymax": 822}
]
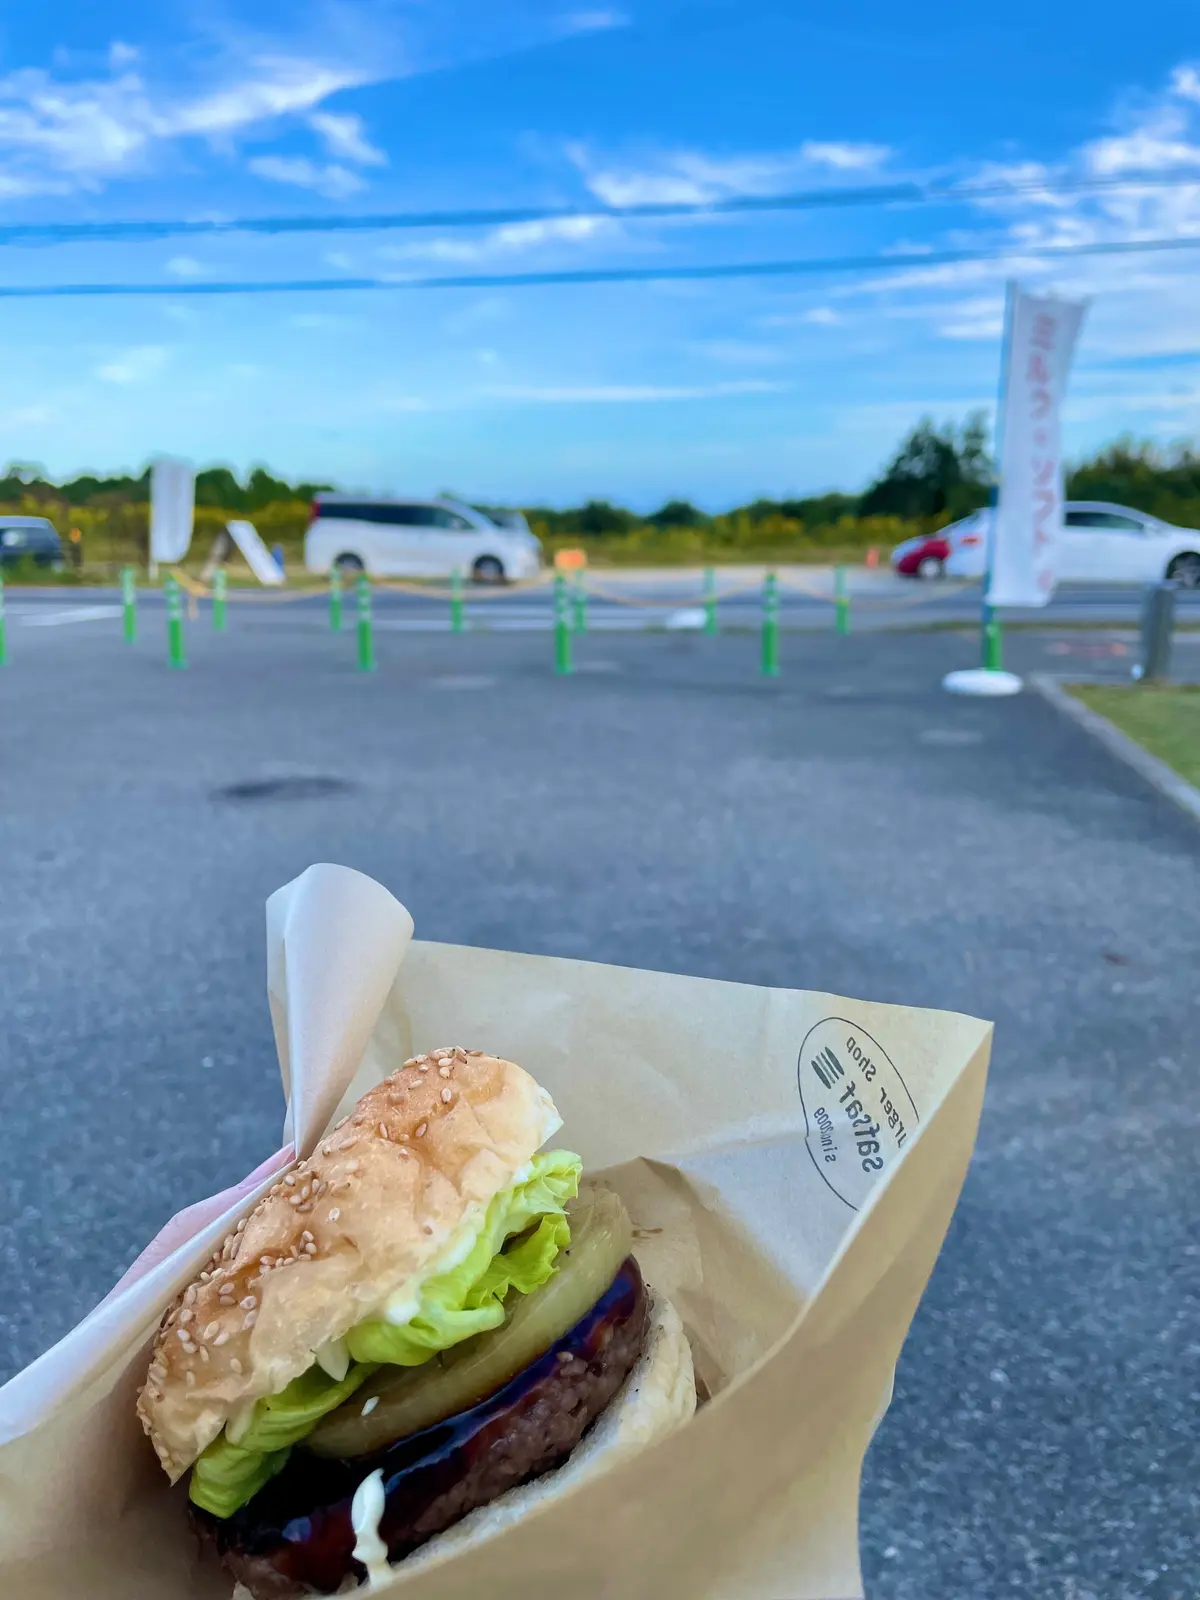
[{"xmin": 797, "ymin": 1016, "xmax": 920, "ymax": 1211}]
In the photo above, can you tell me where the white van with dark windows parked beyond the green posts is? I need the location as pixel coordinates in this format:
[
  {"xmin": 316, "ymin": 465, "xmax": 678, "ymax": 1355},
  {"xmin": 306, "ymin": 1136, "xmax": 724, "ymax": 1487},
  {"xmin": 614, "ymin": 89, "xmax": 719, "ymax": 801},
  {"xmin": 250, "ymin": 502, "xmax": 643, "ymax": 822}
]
[{"xmin": 304, "ymin": 494, "xmax": 542, "ymax": 584}]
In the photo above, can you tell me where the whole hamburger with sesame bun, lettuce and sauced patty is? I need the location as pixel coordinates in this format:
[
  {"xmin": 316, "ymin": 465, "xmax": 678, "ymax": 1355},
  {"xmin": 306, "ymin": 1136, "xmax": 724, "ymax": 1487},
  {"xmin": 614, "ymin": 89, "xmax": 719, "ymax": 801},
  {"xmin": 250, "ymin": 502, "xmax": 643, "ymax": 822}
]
[{"xmin": 138, "ymin": 1048, "xmax": 696, "ymax": 1600}]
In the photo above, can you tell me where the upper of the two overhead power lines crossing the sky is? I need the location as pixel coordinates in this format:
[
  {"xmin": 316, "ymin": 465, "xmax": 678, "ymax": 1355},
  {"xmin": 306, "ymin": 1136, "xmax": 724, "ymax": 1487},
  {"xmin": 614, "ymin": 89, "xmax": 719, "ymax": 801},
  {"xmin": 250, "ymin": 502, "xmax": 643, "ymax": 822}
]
[{"xmin": 0, "ymin": 171, "xmax": 1200, "ymax": 245}]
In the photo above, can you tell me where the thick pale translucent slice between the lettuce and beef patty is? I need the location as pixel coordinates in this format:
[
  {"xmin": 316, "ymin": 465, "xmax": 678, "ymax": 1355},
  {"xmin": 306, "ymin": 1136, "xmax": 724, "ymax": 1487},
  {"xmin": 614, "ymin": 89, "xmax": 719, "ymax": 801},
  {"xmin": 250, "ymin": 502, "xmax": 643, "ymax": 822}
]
[{"xmin": 304, "ymin": 1194, "xmax": 634, "ymax": 1459}]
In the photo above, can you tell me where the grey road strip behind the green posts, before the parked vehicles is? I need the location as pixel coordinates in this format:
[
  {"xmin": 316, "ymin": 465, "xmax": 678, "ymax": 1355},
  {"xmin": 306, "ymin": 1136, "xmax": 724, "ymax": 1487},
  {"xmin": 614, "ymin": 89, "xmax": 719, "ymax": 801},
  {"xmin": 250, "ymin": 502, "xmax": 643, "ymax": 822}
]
[{"xmin": 6, "ymin": 566, "xmax": 1200, "ymax": 632}]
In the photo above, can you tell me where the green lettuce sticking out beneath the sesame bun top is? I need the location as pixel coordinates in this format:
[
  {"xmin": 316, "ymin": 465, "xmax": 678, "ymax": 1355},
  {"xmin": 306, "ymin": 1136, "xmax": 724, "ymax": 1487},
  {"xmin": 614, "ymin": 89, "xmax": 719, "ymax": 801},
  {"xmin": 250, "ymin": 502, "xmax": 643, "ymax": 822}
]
[{"xmin": 189, "ymin": 1150, "xmax": 582, "ymax": 1517}]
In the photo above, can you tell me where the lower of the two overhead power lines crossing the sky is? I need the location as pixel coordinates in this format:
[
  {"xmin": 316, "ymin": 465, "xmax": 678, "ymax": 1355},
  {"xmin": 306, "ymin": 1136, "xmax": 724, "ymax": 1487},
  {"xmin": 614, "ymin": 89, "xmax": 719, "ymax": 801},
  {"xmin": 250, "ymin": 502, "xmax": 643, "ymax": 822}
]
[{"xmin": 0, "ymin": 237, "xmax": 1200, "ymax": 299}]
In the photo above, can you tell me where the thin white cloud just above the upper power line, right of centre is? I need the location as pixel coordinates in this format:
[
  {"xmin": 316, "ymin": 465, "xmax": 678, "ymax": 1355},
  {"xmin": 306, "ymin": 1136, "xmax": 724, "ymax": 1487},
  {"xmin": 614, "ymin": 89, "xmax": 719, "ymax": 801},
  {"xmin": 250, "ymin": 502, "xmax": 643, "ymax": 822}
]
[{"xmin": 566, "ymin": 141, "xmax": 890, "ymax": 206}]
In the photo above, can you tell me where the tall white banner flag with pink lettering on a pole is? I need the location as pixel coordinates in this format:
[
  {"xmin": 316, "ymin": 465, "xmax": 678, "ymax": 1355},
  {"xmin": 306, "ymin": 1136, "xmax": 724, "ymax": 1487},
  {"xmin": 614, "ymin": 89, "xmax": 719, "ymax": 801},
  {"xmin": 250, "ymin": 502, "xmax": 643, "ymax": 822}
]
[{"xmin": 987, "ymin": 283, "xmax": 1088, "ymax": 606}]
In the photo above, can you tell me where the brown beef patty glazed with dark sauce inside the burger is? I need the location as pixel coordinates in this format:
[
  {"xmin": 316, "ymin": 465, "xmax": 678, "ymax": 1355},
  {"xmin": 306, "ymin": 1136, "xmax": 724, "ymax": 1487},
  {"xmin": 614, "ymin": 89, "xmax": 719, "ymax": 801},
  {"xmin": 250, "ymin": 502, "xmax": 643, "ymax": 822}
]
[{"xmin": 192, "ymin": 1256, "xmax": 648, "ymax": 1600}]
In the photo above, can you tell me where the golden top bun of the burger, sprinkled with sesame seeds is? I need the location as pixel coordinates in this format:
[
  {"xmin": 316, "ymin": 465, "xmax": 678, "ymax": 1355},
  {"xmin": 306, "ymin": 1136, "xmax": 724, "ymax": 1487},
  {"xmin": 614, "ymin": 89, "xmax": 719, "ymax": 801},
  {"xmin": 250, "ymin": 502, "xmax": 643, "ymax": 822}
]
[{"xmin": 138, "ymin": 1048, "xmax": 560, "ymax": 1482}]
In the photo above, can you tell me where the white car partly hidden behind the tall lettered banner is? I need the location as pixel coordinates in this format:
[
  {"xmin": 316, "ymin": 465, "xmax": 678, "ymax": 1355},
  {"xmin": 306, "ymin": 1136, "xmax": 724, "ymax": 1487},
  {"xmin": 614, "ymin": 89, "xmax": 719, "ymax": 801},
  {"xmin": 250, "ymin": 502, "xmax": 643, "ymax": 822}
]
[{"xmin": 946, "ymin": 501, "xmax": 1200, "ymax": 589}]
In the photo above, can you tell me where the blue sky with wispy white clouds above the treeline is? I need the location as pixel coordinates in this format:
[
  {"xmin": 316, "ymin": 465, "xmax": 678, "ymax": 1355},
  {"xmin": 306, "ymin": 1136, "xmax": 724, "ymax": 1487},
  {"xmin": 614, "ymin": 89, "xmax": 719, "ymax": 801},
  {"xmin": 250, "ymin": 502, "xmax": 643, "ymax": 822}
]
[{"xmin": 0, "ymin": 0, "xmax": 1200, "ymax": 509}]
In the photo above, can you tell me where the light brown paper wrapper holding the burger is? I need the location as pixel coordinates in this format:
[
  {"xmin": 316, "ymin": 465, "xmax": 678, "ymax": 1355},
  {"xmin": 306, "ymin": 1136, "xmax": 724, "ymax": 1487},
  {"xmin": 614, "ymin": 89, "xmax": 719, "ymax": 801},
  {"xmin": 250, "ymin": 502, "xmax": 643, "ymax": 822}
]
[{"xmin": 0, "ymin": 866, "xmax": 990, "ymax": 1600}]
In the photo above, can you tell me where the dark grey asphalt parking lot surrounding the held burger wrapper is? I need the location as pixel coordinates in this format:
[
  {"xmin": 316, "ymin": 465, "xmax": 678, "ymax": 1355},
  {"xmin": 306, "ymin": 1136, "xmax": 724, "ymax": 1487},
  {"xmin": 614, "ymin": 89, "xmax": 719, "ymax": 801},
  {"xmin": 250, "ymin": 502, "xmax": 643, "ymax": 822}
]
[{"xmin": 0, "ymin": 626, "xmax": 1200, "ymax": 1600}]
